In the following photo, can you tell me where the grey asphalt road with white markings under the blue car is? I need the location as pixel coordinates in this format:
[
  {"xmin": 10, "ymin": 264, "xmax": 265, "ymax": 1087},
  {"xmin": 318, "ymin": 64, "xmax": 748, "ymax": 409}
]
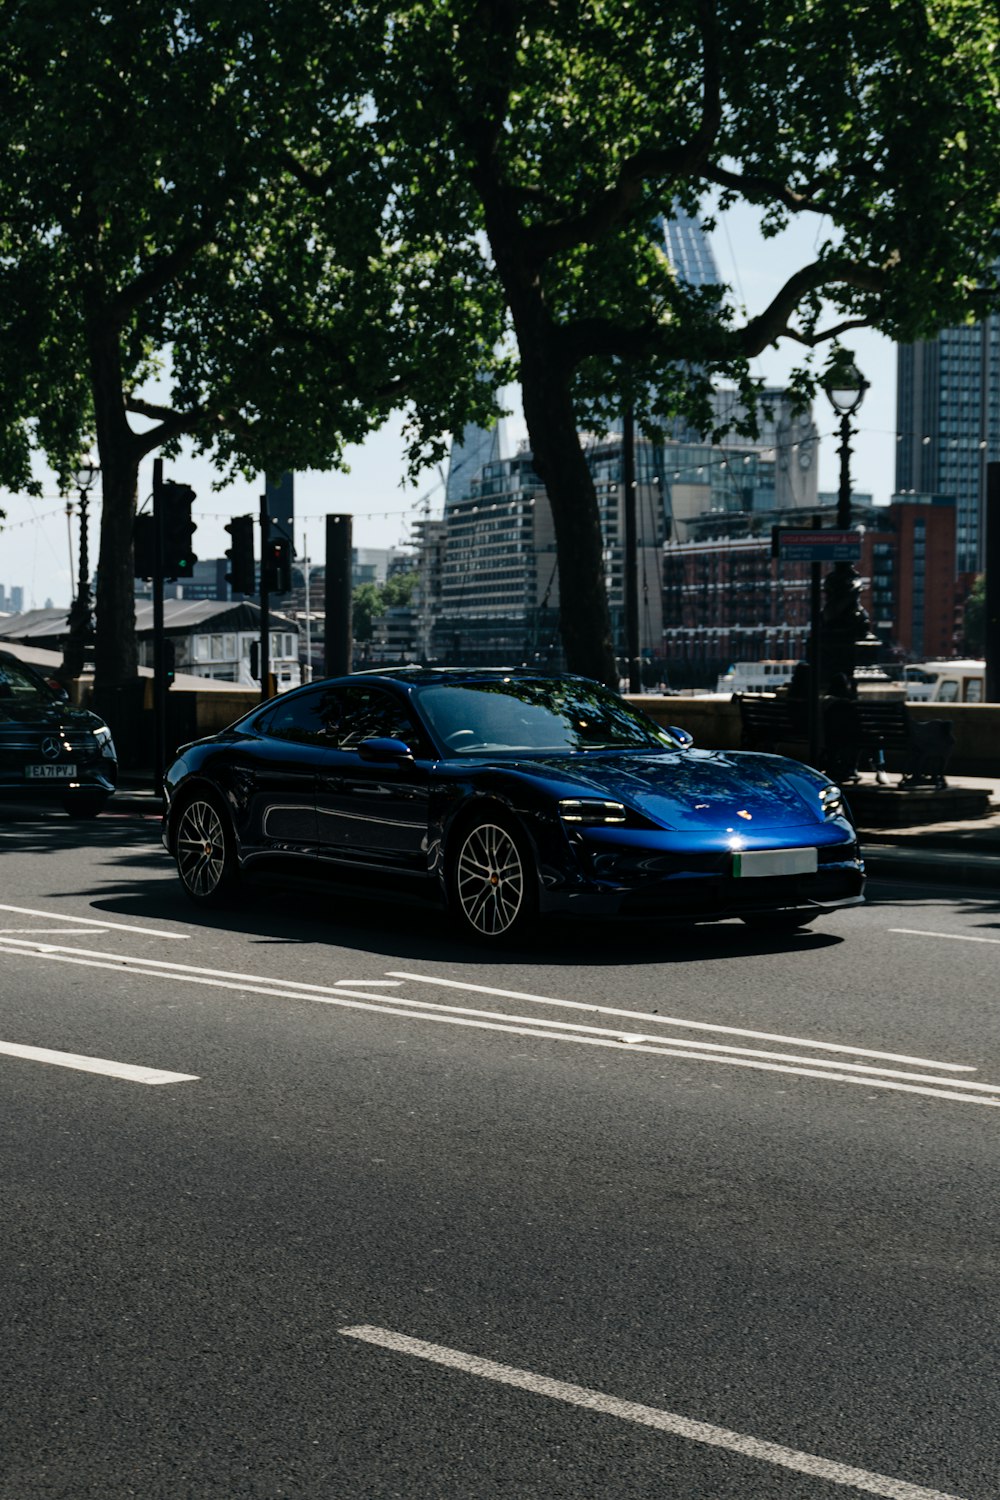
[{"xmin": 0, "ymin": 810, "xmax": 1000, "ymax": 1500}]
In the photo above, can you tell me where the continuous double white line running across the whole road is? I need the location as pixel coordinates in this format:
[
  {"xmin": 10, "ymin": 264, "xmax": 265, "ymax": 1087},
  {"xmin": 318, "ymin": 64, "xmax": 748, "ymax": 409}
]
[{"xmin": 0, "ymin": 939, "xmax": 1000, "ymax": 1109}]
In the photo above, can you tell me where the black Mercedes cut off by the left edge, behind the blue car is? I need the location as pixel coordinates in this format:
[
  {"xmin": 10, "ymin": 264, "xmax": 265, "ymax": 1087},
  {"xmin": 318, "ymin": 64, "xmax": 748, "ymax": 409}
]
[{"xmin": 0, "ymin": 651, "xmax": 118, "ymax": 818}]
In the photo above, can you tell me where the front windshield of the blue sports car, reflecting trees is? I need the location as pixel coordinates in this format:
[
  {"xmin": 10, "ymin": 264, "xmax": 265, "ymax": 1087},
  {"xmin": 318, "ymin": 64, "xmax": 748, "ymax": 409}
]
[{"xmin": 417, "ymin": 678, "xmax": 678, "ymax": 755}]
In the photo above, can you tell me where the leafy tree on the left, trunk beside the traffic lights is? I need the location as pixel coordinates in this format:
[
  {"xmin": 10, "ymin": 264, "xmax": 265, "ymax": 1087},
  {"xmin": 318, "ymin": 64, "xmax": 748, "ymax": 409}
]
[{"xmin": 0, "ymin": 0, "xmax": 509, "ymax": 687}]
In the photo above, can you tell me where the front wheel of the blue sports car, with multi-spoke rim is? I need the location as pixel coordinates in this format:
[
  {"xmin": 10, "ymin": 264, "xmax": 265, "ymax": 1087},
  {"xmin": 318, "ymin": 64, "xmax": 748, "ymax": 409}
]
[{"xmin": 450, "ymin": 810, "xmax": 538, "ymax": 944}]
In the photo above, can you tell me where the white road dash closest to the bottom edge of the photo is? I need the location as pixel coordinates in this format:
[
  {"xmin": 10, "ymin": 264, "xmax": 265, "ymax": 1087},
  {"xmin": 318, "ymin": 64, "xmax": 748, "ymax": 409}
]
[{"xmin": 339, "ymin": 1325, "xmax": 961, "ymax": 1500}]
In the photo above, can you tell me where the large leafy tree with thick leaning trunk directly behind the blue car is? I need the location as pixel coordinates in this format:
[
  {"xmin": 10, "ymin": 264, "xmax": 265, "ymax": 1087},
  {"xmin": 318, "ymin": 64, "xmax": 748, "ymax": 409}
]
[{"xmin": 375, "ymin": 0, "xmax": 1000, "ymax": 681}]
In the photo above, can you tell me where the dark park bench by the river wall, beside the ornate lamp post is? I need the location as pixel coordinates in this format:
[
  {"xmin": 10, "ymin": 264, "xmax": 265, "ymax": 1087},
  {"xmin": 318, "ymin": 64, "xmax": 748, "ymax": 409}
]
[{"xmin": 738, "ymin": 693, "xmax": 955, "ymax": 788}]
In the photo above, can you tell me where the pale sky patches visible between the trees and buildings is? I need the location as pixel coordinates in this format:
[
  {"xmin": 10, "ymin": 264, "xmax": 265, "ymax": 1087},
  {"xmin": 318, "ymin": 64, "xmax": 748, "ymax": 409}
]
[{"xmin": 0, "ymin": 206, "xmax": 897, "ymax": 609}]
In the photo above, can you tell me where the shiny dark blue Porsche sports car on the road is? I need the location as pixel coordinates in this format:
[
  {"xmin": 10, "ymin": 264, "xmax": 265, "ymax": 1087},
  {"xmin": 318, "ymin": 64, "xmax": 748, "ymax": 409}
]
[{"xmin": 163, "ymin": 668, "xmax": 864, "ymax": 942}]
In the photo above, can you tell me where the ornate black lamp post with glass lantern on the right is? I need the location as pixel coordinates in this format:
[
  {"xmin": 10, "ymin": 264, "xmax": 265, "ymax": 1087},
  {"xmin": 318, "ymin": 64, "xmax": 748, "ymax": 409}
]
[{"xmin": 822, "ymin": 350, "xmax": 874, "ymax": 683}]
